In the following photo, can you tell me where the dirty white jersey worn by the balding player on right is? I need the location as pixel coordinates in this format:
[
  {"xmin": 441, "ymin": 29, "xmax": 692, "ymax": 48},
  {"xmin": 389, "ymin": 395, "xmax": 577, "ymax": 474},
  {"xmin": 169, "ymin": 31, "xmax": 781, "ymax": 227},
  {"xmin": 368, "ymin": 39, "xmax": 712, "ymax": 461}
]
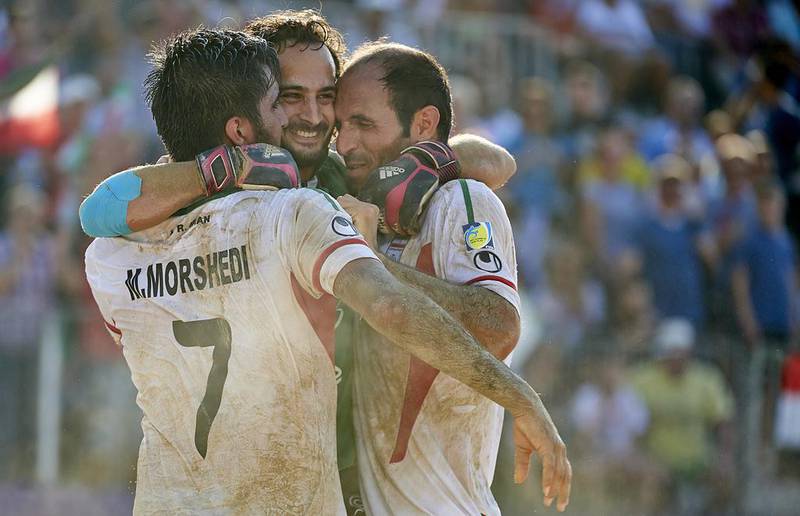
[{"xmin": 354, "ymin": 180, "xmax": 519, "ymax": 515}]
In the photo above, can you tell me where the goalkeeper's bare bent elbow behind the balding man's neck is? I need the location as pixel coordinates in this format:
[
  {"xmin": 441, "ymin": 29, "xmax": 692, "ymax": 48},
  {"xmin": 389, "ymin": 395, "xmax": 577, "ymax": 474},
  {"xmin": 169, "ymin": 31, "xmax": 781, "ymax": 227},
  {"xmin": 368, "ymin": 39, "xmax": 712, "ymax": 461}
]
[{"xmin": 450, "ymin": 134, "xmax": 517, "ymax": 190}]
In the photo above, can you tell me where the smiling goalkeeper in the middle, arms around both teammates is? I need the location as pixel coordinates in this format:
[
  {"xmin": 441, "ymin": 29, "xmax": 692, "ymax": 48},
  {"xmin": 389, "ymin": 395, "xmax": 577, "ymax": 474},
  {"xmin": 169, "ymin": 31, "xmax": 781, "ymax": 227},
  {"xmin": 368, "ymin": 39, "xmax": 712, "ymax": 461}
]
[{"xmin": 76, "ymin": 10, "xmax": 515, "ymax": 509}]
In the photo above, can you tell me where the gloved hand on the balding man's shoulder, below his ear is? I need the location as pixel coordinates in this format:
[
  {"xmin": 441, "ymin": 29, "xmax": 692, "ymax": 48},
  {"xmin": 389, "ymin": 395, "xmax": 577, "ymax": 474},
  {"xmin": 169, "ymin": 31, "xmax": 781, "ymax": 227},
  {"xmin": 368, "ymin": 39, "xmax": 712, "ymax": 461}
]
[{"xmin": 358, "ymin": 141, "xmax": 460, "ymax": 236}]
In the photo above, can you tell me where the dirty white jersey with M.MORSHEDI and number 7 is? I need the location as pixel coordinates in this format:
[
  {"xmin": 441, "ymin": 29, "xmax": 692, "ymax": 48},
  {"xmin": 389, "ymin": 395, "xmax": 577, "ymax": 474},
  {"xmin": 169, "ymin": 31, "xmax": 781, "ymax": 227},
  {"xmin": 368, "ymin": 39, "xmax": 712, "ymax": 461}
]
[{"xmin": 86, "ymin": 189, "xmax": 375, "ymax": 514}]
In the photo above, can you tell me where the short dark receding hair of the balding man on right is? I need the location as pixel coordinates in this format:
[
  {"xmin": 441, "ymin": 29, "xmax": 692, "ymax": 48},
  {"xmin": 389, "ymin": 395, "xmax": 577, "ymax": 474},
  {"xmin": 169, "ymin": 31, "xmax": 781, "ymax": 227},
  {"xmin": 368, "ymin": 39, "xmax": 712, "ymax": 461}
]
[{"xmin": 345, "ymin": 41, "xmax": 453, "ymax": 142}]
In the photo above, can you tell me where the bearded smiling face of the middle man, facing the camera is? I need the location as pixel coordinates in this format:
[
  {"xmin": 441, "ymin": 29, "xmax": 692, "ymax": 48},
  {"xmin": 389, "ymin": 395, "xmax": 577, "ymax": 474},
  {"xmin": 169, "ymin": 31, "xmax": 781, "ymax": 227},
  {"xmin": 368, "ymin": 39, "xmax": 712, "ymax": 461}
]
[{"xmin": 278, "ymin": 44, "xmax": 336, "ymax": 181}]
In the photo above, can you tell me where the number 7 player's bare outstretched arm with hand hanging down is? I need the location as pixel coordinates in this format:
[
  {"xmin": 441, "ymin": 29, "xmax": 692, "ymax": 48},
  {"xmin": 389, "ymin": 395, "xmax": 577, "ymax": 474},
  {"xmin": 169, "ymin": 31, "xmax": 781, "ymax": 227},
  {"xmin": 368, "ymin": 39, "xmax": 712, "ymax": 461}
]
[{"xmin": 333, "ymin": 259, "xmax": 572, "ymax": 510}]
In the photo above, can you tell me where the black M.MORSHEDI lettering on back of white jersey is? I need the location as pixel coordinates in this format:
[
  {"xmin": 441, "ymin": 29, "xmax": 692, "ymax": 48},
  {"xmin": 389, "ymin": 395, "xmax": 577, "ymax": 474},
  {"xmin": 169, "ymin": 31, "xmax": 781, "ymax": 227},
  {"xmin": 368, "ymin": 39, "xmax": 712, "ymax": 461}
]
[{"xmin": 125, "ymin": 245, "xmax": 250, "ymax": 301}]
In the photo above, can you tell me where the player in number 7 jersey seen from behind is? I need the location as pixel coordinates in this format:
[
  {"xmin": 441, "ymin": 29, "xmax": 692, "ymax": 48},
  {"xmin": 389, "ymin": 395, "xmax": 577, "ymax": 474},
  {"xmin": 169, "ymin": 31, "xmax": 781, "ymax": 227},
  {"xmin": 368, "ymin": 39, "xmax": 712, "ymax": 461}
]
[{"xmin": 86, "ymin": 29, "xmax": 566, "ymax": 514}]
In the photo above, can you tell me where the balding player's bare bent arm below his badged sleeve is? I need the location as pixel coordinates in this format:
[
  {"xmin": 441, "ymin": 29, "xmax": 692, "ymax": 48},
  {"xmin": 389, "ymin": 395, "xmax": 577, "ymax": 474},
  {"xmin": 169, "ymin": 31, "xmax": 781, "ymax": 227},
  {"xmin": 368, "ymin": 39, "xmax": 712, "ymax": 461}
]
[{"xmin": 379, "ymin": 255, "xmax": 520, "ymax": 360}]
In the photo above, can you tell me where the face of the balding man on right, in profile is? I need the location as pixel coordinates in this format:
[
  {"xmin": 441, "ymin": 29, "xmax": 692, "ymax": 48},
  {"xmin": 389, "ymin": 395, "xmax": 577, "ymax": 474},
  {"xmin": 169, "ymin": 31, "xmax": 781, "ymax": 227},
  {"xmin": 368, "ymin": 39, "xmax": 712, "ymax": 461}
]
[{"xmin": 336, "ymin": 64, "xmax": 413, "ymax": 191}]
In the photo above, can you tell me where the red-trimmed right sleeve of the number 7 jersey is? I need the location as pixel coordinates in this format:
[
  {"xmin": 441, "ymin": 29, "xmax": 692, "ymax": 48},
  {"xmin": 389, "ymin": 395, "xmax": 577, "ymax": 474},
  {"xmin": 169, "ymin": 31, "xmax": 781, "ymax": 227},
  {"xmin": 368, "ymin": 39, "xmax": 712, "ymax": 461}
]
[{"xmin": 281, "ymin": 188, "xmax": 378, "ymax": 297}]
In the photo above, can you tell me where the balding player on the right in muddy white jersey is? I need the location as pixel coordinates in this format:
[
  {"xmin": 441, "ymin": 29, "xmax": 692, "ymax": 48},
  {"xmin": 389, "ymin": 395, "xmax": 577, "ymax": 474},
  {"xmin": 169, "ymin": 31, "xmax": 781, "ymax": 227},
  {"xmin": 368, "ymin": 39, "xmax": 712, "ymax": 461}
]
[{"xmin": 336, "ymin": 42, "xmax": 571, "ymax": 514}]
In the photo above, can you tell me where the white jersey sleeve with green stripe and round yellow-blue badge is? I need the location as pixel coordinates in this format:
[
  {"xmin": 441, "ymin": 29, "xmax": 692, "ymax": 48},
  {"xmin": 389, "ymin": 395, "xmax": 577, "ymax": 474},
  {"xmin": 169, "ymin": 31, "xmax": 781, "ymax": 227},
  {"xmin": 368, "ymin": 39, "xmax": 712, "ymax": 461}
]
[{"xmin": 431, "ymin": 179, "xmax": 520, "ymax": 311}]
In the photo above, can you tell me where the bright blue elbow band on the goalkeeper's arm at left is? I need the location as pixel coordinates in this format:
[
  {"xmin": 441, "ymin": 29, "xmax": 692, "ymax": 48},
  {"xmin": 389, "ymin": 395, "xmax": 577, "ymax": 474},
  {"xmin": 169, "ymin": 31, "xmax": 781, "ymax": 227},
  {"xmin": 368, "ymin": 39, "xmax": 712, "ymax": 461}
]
[{"xmin": 78, "ymin": 170, "xmax": 142, "ymax": 237}]
